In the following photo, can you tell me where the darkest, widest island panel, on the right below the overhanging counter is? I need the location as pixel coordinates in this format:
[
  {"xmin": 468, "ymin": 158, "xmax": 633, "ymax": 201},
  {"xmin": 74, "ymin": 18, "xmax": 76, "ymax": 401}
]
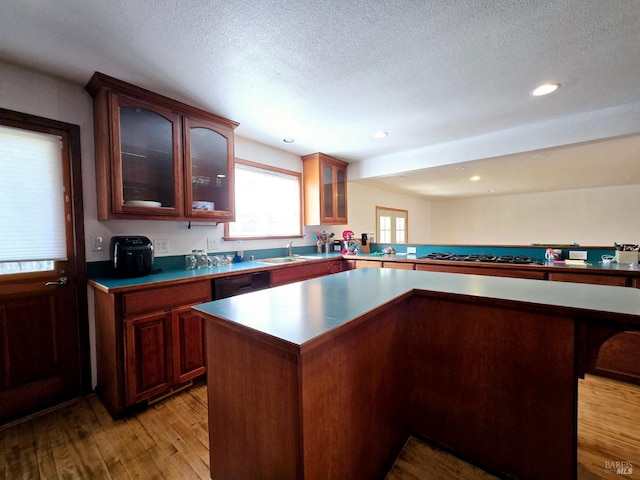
[{"xmin": 406, "ymin": 293, "xmax": 577, "ymax": 480}]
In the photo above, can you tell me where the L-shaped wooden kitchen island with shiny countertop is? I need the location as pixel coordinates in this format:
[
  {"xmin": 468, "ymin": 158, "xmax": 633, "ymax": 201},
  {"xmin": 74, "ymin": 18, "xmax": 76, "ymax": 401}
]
[{"xmin": 194, "ymin": 269, "xmax": 640, "ymax": 480}]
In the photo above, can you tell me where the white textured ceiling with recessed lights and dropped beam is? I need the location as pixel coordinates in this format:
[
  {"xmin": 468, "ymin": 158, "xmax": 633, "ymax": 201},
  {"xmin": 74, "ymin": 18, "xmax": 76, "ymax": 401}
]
[{"xmin": 0, "ymin": 0, "xmax": 640, "ymax": 197}]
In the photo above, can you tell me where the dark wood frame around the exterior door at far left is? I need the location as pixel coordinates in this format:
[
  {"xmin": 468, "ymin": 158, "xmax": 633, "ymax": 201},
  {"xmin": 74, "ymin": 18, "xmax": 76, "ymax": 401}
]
[{"xmin": 0, "ymin": 108, "xmax": 92, "ymax": 395}]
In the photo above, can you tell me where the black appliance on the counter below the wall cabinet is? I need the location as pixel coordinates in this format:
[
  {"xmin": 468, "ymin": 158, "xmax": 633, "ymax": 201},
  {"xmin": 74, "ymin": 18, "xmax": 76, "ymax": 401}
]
[{"xmin": 110, "ymin": 235, "xmax": 153, "ymax": 277}]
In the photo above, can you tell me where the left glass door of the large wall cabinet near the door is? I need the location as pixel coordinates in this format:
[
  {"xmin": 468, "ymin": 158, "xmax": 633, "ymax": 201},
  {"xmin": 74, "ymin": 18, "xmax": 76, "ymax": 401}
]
[{"xmin": 112, "ymin": 95, "xmax": 182, "ymax": 216}]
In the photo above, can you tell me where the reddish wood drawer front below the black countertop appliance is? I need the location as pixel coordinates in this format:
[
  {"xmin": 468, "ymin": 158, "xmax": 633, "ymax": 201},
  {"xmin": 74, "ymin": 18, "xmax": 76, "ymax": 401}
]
[{"xmin": 122, "ymin": 281, "xmax": 211, "ymax": 315}]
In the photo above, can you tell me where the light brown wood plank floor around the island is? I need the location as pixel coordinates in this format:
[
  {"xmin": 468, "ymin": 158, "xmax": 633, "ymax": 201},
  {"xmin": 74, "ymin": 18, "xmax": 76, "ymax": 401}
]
[{"xmin": 0, "ymin": 376, "xmax": 640, "ymax": 480}]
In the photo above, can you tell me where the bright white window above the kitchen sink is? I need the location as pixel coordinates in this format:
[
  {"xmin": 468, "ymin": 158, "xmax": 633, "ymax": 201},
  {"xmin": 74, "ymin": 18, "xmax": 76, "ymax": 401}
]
[{"xmin": 224, "ymin": 159, "xmax": 302, "ymax": 239}]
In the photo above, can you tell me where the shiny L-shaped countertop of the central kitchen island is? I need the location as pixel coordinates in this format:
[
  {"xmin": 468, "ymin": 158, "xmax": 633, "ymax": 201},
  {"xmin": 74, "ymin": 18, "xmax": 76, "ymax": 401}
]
[{"xmin": 194, "ymin": 268, "xmax": 640, "ymax": 347}]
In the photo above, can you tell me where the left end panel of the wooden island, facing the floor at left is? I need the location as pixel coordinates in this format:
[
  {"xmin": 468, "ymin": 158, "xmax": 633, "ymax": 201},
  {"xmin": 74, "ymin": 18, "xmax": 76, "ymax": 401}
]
[{"xmin": 205, "ymin": 318, "xmax": 302, "ymax": 480}]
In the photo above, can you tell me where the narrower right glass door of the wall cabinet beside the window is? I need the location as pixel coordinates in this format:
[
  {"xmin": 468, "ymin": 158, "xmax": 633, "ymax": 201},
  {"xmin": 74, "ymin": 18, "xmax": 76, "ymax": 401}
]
[{"xmin": 184, "ymin": 117, "xmax": 234, "ymax": 219}]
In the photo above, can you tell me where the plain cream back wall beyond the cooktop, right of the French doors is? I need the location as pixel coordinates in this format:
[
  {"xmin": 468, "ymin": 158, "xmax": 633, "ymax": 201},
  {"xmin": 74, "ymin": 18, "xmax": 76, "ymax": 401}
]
[{"xmin": 431, "ymin": 185, "xmax": 640, "ymax": 246}]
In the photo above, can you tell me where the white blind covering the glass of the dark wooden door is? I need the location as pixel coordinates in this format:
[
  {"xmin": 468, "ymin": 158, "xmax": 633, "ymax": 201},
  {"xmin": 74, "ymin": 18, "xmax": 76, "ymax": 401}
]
[{"xmin": 0, "ymin": 126, "xmax": 67, "ymax": 262}]
